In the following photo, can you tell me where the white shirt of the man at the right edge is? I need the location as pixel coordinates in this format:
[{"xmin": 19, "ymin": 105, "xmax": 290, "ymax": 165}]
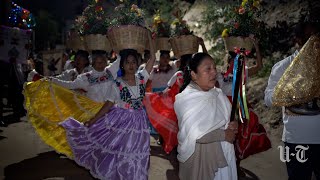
[{"xmin": 264, "ymin": 51, "xmax": 320, "ymax": 144}]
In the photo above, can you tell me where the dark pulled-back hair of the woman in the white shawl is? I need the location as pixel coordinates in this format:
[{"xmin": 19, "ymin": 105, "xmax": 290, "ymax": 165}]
[{"xmin": 180, "ymin": 52, "xmax": 211, "ymax": 92}]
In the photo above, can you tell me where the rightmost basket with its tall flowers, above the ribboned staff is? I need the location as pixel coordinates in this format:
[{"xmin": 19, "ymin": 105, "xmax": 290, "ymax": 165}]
[{"xmin": 222, "ymin": 0, "xmax": 260, "ymax": 50}]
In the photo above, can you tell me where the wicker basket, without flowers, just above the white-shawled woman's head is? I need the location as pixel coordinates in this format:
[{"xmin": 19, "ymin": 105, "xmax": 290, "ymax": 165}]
[{"xmin": 170, "ymin": 35, "xmax": 199, "ymax": 58}]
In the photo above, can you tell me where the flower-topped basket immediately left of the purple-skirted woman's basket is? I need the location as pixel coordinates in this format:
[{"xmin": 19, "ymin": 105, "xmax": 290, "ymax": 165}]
[{"xmin": 75, "ymin": 0, "xmax": 111, "ymax": 51}]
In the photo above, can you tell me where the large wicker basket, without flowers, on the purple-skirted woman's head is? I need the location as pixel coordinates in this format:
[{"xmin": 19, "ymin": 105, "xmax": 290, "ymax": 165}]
[{"xmin": 108, "ymin": 25, "xmax": 149, "ymax": 53}]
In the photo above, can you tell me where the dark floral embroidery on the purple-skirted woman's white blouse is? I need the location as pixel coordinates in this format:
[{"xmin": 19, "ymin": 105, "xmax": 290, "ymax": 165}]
[{"xmin": 115, "ymin": 73, "xmax": 146, "ymax": 109}]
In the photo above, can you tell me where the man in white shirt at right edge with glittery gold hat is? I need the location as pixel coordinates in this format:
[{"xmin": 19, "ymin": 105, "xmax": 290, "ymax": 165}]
[{"xmin": 264, "ymin": 19, "xmax": 320, "ymax": 180}]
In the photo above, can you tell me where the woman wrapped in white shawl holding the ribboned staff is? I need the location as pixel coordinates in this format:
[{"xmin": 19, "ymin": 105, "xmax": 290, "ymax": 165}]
[{"xmin": 174, "ymin": 53, "xmax": 237, "ymax": 180}]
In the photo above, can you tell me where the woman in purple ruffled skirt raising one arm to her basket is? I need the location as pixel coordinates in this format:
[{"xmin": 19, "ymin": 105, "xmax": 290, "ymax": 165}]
[{"xmin": 61, "ymin": 36, "xmax": 155, "ymax": 179}]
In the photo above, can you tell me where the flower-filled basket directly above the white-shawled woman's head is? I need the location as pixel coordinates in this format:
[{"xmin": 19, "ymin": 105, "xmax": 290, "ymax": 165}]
[{"xmin": 170, "ymin": 9, "xmax": 199, "ymax": 57}]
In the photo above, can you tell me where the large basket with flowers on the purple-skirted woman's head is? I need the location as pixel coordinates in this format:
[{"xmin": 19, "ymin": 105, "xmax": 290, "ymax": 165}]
[{"xmin": 108, "ymin": 3, "xmax": 149, "ymax": 53}]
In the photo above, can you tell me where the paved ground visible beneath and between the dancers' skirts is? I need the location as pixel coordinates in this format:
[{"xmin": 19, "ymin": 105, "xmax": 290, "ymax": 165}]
[{"xmin": 0, "ymin": 114, "xmax": 287, "ymax": 180}]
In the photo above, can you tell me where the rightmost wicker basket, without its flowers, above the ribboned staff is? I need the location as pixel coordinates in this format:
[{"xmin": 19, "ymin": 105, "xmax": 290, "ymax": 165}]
[{"xmin": 223, "ymin": 36, "xmax": 253, "ymax": 51}]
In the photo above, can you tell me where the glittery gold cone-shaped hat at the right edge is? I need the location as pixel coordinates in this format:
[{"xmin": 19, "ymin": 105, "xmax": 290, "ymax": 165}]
[{"xmin": 272, "ymin": 34, "xmax": 320, "ymax": 106}]
